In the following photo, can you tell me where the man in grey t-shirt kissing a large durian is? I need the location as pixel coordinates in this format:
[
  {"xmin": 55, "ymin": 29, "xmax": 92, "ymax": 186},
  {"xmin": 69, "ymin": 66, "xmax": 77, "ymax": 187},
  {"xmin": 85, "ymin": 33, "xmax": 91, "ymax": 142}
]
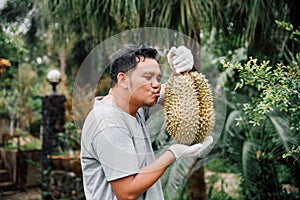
[{"xmin": 81, "ymin": 45, "xmax": 212, "ymax": 200}]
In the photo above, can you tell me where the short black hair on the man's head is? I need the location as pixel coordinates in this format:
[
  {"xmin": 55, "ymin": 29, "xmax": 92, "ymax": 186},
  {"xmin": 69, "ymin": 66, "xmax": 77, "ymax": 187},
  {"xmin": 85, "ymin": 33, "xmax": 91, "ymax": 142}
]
[{"xmin": 109, "ymin": 44, "xmax": 158, "ymax": 87}]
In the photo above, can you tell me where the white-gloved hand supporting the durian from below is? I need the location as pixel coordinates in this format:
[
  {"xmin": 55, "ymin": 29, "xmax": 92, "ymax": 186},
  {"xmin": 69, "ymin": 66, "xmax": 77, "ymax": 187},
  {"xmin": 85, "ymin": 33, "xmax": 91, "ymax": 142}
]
[{"xmin": 168, "ymin": 136, "xmax": 213, "ymax": 160}]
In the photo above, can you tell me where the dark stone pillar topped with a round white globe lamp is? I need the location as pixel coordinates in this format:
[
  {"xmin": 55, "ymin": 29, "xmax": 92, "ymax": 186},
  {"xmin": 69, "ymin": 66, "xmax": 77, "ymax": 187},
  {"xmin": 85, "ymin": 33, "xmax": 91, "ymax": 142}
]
[{"xmin": 42, "ymin": 69, "xmax": 66, "ymax": 199}]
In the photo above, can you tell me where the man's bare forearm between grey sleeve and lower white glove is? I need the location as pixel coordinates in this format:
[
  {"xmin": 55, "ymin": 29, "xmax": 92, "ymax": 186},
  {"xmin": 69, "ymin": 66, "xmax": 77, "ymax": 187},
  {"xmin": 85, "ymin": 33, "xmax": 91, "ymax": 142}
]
[{"xmin": 110, "ymin": 151, "xmax": 175, "ymax": 199}]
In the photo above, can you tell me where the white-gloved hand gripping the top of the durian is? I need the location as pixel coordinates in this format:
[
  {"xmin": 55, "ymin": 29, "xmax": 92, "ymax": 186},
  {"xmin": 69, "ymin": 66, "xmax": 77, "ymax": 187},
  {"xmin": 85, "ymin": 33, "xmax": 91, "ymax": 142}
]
[{"xmin": 167, "ymin": 46, "xmax": 194, "ymax": 74}]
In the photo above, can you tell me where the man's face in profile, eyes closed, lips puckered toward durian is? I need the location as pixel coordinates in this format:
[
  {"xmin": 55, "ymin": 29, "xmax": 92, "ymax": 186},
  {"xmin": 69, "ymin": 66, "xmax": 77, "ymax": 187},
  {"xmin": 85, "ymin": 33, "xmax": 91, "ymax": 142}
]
[{"xmin": 128, "ymin": 58, "xmax": 162, "ymax": 107}]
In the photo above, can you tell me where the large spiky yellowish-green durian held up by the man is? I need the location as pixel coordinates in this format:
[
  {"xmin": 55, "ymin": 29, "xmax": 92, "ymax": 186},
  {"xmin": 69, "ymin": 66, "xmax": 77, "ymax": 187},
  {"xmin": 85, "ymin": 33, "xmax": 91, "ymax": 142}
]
[{"xmin": 164, "ymin": 71, "xmax": 215, "ymax": 145}]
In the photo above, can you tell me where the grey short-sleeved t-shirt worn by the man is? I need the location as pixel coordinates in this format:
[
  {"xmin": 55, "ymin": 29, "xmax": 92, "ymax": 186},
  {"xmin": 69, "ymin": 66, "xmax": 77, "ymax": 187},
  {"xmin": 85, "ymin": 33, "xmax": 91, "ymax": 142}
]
[{"xmin": 81, "ymin": 99, "xmax": 164, "ymax": 200}]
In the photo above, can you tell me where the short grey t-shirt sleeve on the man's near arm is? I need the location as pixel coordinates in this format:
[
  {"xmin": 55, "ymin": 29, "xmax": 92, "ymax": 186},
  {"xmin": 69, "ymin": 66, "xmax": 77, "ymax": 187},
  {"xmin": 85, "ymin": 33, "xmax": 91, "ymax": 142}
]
[{"xmin": 92, "ymin": 127, "xmax": 139, "ymax": 181}]
